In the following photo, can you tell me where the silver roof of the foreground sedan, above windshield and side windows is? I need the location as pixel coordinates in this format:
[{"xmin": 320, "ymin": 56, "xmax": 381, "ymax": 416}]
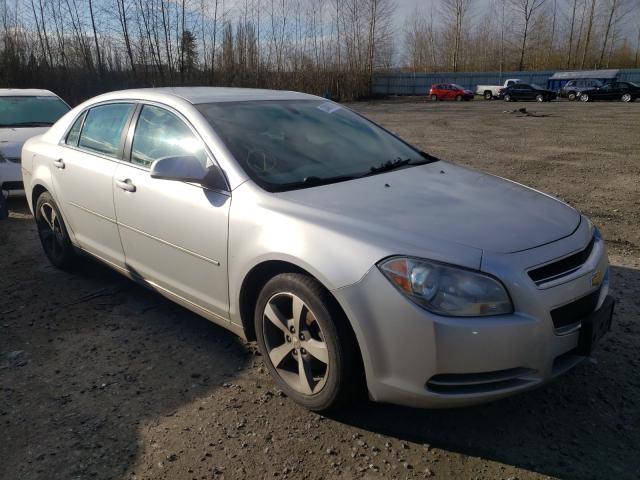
[{"xmin": 86, "ymin": 87, "xmax": 320, "ymax": 105}]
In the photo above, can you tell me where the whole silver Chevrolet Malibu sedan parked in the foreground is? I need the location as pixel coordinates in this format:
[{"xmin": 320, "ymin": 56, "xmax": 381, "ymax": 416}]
[{"xmin": 22, "ymin": 88, "xmax": 614, "ymax": 410}]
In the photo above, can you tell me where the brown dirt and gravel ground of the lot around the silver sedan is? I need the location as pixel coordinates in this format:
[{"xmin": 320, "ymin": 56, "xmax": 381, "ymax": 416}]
[{"xmin": 0, "ymin": 101, "xmax": 640, "ymax": 480}]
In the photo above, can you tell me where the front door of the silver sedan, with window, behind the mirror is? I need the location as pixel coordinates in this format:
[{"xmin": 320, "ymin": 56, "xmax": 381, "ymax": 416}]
[{"xmin": 114, "ymin": 105, "xmax": 231, "ymax": 319}]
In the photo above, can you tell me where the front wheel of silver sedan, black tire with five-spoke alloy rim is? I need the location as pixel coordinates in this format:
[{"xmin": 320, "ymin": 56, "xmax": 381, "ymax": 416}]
[{"xmin": 254, "ymin": 273, "xmax": 363, "ymax": 411}]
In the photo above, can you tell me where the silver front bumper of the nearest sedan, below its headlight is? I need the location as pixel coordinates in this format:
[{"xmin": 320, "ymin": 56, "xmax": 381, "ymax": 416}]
[{"xmin": 334, "ymin": 222, "xmax": 610, "ymax": 408}]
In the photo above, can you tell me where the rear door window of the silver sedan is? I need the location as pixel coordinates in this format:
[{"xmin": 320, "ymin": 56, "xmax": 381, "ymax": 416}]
[{"xmin": 78, "ymin": 103, "xmax": 134, "ymax": 157}]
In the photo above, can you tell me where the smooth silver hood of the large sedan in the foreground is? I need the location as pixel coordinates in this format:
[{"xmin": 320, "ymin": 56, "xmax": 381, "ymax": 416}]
[{"xmin": 279, "ymin": 161, "xmax": 580, "ymax": 253}]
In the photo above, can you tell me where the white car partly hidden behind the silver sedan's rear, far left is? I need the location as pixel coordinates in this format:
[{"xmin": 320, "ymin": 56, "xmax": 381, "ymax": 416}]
[{"xmin": 0, "ymin": 88, "xmax": 70, "ymax": 196}]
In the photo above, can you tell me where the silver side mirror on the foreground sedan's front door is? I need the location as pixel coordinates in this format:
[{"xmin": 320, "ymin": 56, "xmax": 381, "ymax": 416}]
[{"xmin": 150, "ymin": 155, "xmax": 227, "ymax": 190}]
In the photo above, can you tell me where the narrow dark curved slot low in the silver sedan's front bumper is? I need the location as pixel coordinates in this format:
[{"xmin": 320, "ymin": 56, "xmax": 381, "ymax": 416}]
[{"xmin": 427, "ymin": 367, "xmax": 536, "ymax": 395}]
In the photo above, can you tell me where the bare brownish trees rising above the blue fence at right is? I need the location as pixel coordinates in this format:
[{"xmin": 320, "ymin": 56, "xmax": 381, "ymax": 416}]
[{"xmin": 405, "ymin": 0, "xmax": 640, "ymax": 72}]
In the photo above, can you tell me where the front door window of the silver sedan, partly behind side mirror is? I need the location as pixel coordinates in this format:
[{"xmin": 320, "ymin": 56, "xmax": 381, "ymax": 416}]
[{"xmin": 131, "ymin": 105, "xmax": 209, "ymax": 167}]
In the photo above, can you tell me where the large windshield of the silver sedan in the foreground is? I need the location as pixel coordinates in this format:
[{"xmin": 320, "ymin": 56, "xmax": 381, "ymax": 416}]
[{"xmin": 197, "ymin": 100, "xmax": 435, "ymax": 192}]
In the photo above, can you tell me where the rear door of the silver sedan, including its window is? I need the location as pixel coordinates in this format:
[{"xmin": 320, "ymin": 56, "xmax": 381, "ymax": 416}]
[{"xmin": 52, "ymin": 103, "xmax": 135, "ymax": 267}]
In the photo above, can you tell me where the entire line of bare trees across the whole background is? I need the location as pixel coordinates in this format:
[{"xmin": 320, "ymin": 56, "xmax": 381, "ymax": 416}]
[{"xmin": 0, "ymin": 0, "xmax": 640, "ymax": 103}]
